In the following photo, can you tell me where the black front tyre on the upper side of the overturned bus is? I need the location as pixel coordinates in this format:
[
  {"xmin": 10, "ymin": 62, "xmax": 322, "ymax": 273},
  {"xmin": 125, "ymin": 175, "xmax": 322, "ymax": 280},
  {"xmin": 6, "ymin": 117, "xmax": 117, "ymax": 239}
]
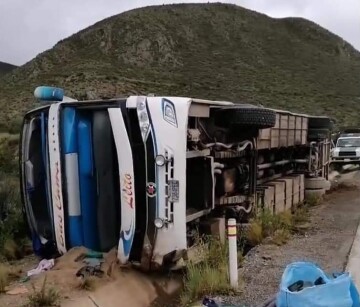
[{"xmin": 215, "ymin": 107, "xmax": 276, "ymax": 129}]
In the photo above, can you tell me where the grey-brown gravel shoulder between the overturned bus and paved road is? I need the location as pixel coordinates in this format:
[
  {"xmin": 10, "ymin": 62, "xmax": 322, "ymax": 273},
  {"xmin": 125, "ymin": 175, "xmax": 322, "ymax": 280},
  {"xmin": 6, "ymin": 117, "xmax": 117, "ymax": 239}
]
[{"xmin": 223, "ymin": 172, "xmax": 360, "ymax": 306}]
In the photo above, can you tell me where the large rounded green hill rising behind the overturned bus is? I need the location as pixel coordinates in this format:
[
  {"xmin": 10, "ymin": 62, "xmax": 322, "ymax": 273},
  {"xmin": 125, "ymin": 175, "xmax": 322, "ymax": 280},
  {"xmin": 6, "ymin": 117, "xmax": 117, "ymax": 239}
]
[{"xmin": 0, "ymin": 3, "xmax": 360, "ymax": 132}]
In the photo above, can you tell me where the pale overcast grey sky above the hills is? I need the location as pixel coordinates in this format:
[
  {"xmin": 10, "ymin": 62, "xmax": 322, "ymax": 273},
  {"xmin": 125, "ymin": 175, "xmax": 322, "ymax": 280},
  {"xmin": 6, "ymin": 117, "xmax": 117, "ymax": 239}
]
[{"xmin": 0, "ymin": 0, "xmax": 360, "ymax": 65}]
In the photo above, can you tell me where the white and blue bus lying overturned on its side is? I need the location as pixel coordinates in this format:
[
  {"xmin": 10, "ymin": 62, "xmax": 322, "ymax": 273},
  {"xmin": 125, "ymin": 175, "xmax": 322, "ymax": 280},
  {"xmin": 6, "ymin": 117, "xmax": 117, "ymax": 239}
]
[{"xmin": 20, "ymin": 87, "xmax": 330, "ymax": 270}]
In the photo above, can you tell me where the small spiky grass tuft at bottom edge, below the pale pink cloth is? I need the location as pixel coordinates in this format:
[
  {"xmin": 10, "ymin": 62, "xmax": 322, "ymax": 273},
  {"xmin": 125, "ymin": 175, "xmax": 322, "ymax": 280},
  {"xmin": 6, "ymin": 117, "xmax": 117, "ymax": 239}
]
[{"xmin": 25, "ymin": 277, "xmax": 60, "ymax": 307}]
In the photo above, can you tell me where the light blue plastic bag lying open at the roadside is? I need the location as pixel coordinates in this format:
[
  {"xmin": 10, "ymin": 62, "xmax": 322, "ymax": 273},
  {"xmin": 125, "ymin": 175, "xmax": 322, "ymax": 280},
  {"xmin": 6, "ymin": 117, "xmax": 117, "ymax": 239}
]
[{"xmin": 276, "ymin": 262, "xmax": 360, "ymax": 307}]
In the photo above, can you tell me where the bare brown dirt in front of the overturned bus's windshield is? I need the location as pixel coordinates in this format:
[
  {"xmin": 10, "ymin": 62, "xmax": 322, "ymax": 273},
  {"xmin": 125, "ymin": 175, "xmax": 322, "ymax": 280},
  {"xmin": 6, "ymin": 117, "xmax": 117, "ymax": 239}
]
[{"xmin": 0, "ymin": 247, "xmax": 181, "ymax": 307}]
